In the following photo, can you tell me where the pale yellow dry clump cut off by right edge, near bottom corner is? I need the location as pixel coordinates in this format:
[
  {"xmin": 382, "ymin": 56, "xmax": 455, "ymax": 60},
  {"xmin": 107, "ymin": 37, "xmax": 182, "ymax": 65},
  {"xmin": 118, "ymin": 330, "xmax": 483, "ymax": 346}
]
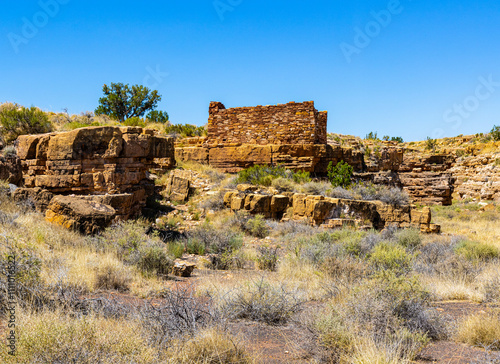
[{"xmin": 456, "ymin": 312, "xmax": 500, "ymax": 350}]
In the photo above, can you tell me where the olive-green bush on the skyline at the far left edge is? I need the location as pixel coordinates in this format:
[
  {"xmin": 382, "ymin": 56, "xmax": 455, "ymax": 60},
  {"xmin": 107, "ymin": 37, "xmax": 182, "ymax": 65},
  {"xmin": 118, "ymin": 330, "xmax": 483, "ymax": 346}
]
[{"xmin": 0, "ymin": 104, "xmax": 52, "ymax": 143}]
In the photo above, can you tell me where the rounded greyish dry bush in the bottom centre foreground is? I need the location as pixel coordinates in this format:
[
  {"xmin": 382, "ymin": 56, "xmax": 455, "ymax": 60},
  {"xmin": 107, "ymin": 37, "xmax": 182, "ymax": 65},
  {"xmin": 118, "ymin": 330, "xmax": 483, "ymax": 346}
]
[{"xmin": 222, "ymin": 278, "xmax": 304, "ymax": 325}]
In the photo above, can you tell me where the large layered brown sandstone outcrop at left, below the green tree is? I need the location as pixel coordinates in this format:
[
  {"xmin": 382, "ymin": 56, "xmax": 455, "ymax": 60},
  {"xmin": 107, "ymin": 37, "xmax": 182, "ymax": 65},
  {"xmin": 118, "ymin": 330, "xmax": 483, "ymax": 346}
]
[{"xmin": 14, "ymin": 127, "xmax": 175, "ymax": 233}]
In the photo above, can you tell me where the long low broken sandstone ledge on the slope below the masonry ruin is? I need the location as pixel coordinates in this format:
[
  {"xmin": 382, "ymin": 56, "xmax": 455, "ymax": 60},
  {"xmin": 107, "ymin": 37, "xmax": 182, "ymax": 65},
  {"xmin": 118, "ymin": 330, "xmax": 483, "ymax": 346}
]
[{"xmin": 224, "ymin": 185, "xmax": 441, "ymax": 233}]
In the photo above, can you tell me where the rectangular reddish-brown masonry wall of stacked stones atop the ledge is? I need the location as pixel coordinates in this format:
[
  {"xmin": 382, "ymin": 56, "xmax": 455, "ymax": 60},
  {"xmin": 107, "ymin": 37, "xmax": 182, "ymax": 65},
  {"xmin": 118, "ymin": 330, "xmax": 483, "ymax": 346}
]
[{"xmin": 207, "ymin": 101, "xmax": 327, "ymax": 145}]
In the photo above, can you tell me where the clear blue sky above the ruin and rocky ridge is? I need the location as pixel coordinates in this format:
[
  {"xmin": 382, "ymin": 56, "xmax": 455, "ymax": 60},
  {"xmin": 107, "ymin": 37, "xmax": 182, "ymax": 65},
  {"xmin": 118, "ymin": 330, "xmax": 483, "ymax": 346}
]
[{"xmin": 0, "ymin": 0, "xmax": 500, "ymax": 140}]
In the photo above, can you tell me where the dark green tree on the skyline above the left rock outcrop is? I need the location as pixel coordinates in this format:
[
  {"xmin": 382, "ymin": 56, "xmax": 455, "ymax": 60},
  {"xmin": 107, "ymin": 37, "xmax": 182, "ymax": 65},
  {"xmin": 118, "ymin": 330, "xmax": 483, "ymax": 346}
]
[{"xmin": 95, "ymin": 83, "xmax": 161, "ymax": 121}]
